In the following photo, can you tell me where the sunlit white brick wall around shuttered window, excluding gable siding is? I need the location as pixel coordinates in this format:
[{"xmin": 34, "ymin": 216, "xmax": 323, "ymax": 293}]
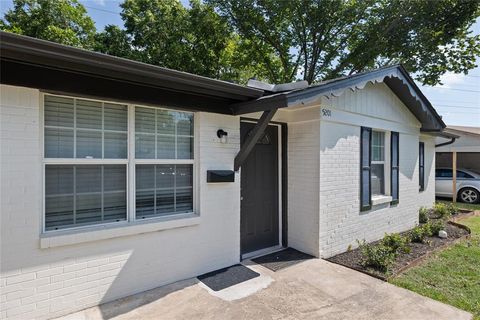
[{"xmin": 320, "ymin": 122, "xmax": 427, "ymax": 257}]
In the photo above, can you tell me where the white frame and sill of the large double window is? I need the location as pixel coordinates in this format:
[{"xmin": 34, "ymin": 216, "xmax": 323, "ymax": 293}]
[{"xmin": 39, "ymin": 92, "xmax": 199, "ymax": 238}]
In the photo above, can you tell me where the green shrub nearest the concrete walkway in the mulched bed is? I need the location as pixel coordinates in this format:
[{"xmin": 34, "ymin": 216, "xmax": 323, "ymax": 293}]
[{"xmin": 359, "ymin": 241, "xmax": 395, "ymax": 272}]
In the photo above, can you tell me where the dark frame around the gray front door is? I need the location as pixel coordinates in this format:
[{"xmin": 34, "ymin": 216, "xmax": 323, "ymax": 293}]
[{"xmin": 240, "ymin": 117, "xmax": 288, "ymax": 252}]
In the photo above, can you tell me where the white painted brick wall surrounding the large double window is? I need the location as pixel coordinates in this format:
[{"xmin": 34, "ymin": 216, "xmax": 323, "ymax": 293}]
[{"xmin": 0, "ymin": 85, "xmax": 240, "ymax": 319}]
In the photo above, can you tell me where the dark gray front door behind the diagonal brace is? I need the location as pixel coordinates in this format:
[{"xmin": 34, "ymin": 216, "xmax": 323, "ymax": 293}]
[{"xmin": 240, "ymin": 122, "xmax": 279, "ymax": 254}]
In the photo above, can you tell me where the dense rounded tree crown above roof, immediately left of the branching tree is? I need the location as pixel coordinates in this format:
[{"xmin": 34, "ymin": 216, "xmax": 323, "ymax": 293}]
[{"xmin": 121, "ymin": 0, "xmax": 235, "ymax": 78}]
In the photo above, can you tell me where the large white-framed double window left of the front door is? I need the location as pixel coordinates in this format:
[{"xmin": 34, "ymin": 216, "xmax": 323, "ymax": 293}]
[{"xmin": 44, "ymin": 95, "xmax": 194, "ymax": 231}]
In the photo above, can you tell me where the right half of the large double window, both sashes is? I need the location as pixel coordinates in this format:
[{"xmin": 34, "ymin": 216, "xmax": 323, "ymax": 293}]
[{"xmin": 135, "ymin": 107, "xmax": 194, "ymax": 219}]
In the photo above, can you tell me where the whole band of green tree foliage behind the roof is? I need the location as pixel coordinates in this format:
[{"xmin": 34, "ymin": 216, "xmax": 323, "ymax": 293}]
[{"xmin": 0, "ymin": 0, "xmax": 480, "ymax": 85}]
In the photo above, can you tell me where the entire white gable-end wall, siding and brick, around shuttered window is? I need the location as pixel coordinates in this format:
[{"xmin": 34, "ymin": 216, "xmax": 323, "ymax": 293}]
[{"xmin": 320, "ymin": 84, "xmax": 435, "ymax": 258}]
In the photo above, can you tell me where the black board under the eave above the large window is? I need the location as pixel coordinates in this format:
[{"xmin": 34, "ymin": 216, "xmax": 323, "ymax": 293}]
[{"xmin": 0, "ymin": 60, "xmax": 236, "ymax": 114}]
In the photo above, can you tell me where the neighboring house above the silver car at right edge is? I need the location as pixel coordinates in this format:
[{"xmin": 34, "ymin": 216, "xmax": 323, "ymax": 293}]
[{"xmin": 435, "ymin": 126, "xmax": 480, "ymax": 172}]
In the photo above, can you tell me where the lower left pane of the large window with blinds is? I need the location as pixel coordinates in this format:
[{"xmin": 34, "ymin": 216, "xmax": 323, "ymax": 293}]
[{"xmin": 45, "ymin": 165, "xmax": 127, "ymax": 231}]
